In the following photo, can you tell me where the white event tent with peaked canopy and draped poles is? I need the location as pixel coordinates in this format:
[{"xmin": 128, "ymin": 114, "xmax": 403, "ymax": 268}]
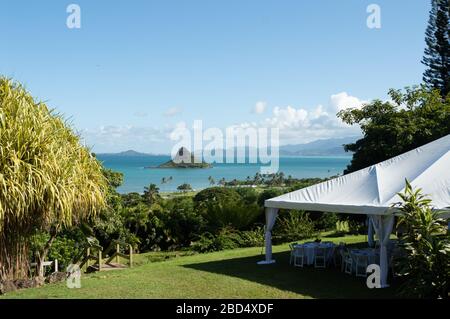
[{"xmin": 260, "ymin": 135, "xmax": 450, "ymax": 287}]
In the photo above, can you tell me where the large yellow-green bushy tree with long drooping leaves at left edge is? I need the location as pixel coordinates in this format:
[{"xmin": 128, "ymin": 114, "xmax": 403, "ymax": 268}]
[{"xmin": 0, "ymin": 78, "xmax": 108, "ymax": 280}]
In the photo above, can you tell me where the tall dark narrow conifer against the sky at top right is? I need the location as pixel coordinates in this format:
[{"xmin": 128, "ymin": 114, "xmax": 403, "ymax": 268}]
[{"xmin": 422, "ymin": 0, "xmax": 450, "ymax": 96}]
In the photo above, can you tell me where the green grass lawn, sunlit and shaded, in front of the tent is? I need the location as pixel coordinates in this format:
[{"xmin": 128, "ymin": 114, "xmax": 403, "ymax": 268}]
[{"xmin": 3, "ymin": 236, "xmax": 395, "ymax": 298}]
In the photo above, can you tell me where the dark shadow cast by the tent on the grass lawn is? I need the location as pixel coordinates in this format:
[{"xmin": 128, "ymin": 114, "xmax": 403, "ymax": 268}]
[{"xmin": 184, "ymin": 245, "xmax": 396, "ymax": 298}]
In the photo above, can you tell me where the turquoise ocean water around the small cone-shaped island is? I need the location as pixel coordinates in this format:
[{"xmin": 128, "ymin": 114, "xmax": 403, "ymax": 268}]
[{"xmin": 97, "ymin": 154, "xmax": 351, "ymax": 193}]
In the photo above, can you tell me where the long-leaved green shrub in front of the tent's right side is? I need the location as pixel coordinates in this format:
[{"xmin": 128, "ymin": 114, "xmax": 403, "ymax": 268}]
[{"xmin": 398, "ymin": 182, "xmax": 450, "ymax": 298}]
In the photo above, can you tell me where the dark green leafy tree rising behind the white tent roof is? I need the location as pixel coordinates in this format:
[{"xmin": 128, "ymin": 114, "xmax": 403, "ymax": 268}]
[{"xmin": 338, "ymin": 87, "xmax": 450, "ymax": 173}]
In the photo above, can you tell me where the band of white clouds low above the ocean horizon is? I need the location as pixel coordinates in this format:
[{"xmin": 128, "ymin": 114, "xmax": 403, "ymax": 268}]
[{"xmin": 81, "ymin": 92, "xmax": 365, "ymax": 153}]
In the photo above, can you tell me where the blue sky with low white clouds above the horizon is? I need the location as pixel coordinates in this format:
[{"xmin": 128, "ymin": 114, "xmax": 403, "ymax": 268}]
[{"xmin": 0, "ymin": 0, "xmax": 430, "ymax": 153}]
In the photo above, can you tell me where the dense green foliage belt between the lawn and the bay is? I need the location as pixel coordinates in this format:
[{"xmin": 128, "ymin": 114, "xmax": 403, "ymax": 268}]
[{"xmin": 33, "ymin": 169, "xmax": 356, "ymax": 265}]
